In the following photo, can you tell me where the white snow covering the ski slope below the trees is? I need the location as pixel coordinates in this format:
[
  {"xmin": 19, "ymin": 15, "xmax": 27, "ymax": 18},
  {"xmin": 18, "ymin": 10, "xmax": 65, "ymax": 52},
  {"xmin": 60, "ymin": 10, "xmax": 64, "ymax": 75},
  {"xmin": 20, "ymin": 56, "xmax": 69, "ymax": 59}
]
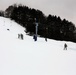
[{"xmin": 0, "ymin": 17, "xmax": 76, "ymax": 75}]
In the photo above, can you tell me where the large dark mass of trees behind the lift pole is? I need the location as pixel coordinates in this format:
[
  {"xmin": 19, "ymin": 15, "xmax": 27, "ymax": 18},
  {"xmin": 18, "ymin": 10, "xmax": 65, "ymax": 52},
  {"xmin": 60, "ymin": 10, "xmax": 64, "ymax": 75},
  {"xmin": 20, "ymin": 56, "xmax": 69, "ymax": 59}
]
[{"xmin": 0, "ymin": 4, "xmax": 76, "ymax": 42}]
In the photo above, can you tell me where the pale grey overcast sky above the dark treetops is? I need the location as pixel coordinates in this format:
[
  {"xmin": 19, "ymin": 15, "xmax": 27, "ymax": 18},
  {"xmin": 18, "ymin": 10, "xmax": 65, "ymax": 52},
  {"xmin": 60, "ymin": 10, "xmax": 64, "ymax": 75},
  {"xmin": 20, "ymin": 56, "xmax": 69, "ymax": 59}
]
[{"xmin": 0, "ymin": 0, "xmax": 76, "ymax": 25}]
